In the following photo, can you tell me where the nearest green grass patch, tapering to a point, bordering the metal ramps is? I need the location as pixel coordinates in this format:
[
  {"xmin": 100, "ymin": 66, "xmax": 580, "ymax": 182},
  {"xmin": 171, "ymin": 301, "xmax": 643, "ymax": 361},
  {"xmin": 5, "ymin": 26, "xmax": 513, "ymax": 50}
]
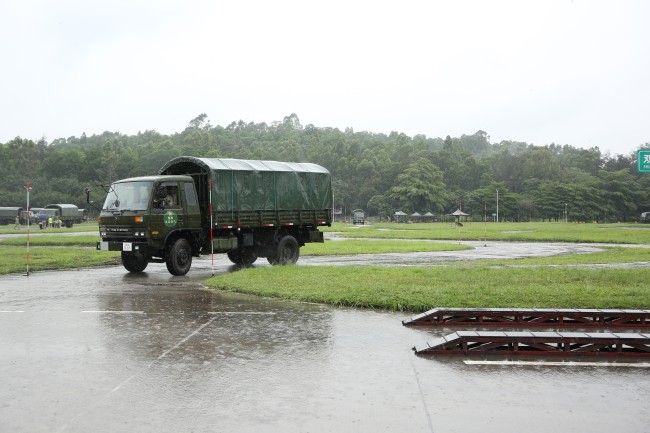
[{"xmin": 206, "ymin": 265, "xmax": 650, "ymax": 312}]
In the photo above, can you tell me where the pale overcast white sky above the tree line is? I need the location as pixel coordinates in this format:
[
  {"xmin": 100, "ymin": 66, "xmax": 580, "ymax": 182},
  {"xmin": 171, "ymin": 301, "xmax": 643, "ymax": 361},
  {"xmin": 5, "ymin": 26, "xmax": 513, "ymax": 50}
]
[{"xmin": 0, "ymin": 0, "xmax": 650, "ymax": 155}]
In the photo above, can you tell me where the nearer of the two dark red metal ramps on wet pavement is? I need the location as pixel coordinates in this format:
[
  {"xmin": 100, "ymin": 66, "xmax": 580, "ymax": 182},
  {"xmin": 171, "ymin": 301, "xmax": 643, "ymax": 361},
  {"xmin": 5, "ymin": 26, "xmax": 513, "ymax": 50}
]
[{"xmin": 413, "ymin": 331, "xmax": 650, "ymax": 357}]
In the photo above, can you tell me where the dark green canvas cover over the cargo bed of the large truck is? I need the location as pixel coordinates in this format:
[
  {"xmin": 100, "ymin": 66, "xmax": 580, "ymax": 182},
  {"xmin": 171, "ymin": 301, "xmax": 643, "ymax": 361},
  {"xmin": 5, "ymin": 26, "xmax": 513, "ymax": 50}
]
[{"xmin": 160, "ymin": 156, "xmax": 332, "ymax": 212}]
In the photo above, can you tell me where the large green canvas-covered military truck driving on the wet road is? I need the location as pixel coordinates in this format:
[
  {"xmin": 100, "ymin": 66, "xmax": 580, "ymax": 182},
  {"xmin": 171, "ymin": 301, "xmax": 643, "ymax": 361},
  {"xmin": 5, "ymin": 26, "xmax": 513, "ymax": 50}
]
[{"xmin": 93, "ymin": 156, "xmax": 332, "ymax": 275}]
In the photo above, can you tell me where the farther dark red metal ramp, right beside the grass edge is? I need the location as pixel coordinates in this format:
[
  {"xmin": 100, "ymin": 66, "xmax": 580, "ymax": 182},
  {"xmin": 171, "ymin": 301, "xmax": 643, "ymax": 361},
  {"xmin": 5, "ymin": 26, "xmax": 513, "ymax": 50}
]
[{"xmin": 402, "ymin": 308, "xmax": 650, "ymax": 328}]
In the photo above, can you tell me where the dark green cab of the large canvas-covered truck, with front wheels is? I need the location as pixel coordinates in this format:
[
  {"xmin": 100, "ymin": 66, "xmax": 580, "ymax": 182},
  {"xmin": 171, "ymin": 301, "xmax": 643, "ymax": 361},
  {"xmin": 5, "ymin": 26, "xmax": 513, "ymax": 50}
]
[{"xmin": 97, "ymin": 175, "xmax": 202, "ymax": 275}]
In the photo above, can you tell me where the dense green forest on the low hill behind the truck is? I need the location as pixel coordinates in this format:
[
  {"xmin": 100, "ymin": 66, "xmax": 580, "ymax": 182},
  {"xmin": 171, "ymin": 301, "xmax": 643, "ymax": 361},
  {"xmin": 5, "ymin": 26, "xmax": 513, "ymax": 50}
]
[{"xmin": 0, "ymin": 114, "xmax": 650, "ymax": 222}]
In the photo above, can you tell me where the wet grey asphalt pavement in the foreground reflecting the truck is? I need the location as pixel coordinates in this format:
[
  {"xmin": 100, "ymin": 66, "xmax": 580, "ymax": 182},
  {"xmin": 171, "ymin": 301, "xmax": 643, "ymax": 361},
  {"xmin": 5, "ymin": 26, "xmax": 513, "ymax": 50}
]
[{"xmin": 0, "ymin": 244, "xmax": 650, "ymax": 433}]
